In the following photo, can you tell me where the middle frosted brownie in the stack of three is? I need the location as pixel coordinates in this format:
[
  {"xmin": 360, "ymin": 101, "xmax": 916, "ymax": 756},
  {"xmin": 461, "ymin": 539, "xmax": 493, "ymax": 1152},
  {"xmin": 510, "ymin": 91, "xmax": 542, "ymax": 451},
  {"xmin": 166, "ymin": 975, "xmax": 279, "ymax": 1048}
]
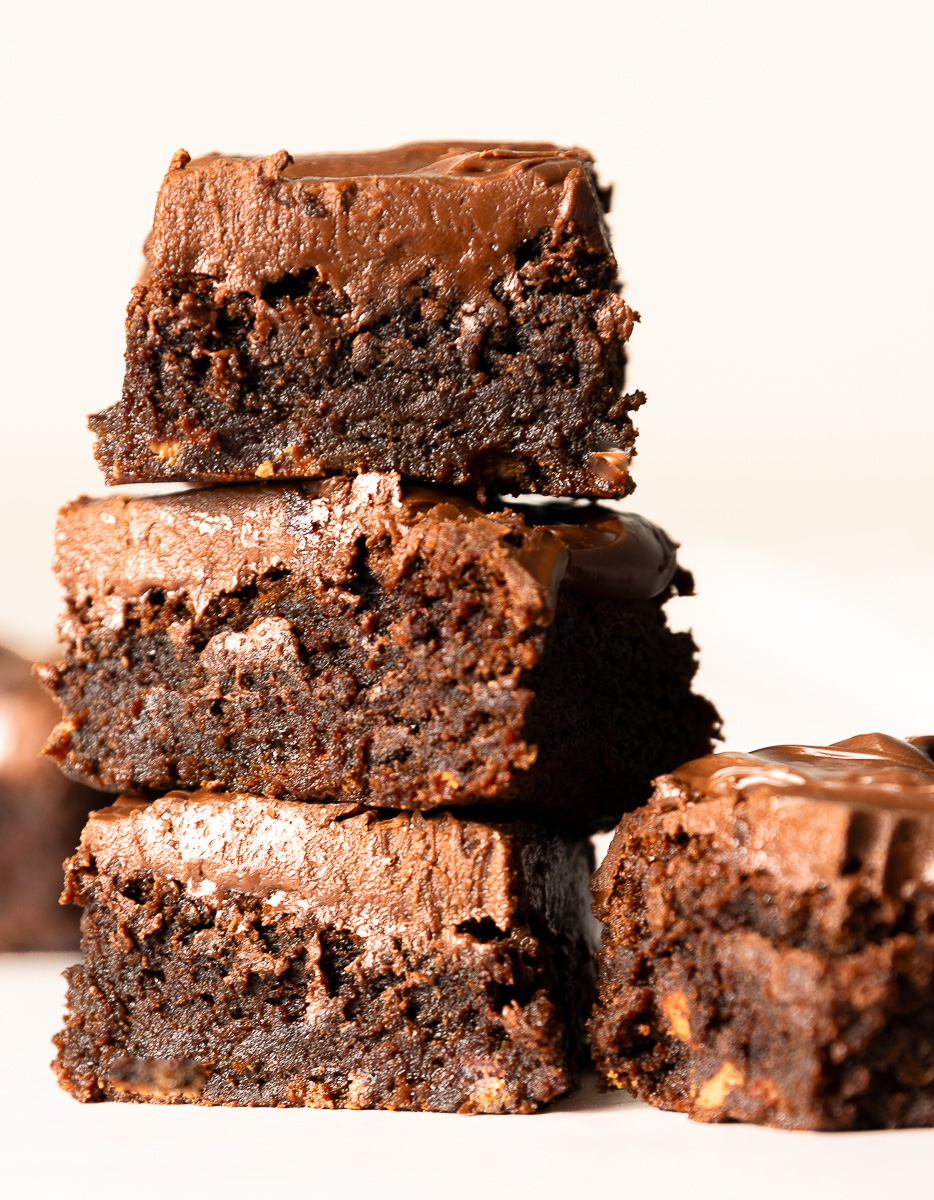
[{"xmin": 41, "ymin": 474, "xmax": 718, "ymax": 829}]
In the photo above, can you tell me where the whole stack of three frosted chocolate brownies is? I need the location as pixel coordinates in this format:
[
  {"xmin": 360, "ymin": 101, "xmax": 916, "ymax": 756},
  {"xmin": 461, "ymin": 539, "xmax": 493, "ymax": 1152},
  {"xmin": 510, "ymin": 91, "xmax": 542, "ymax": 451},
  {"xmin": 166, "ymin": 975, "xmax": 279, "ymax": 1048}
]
[{"xmin": 41, "ymin": 143, "xmax": 718, "ymax": 1112}]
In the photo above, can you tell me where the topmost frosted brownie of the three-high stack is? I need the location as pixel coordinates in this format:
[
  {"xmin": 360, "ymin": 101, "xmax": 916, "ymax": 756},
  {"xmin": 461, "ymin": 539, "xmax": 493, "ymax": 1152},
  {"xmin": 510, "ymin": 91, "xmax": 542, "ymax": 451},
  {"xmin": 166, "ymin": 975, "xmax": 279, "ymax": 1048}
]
[{"xmin": 90, "ymin": 142, "xmax": 645, "ymax": 496}]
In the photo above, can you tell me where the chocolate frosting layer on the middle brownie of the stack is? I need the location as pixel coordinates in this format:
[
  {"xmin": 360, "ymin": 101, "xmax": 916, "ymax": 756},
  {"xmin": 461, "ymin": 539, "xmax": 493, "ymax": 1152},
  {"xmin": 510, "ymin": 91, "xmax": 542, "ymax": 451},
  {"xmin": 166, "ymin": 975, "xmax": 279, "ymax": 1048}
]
[{"xmin": 55, "ymin": 473, "xmax": 677, "ymax": 625}]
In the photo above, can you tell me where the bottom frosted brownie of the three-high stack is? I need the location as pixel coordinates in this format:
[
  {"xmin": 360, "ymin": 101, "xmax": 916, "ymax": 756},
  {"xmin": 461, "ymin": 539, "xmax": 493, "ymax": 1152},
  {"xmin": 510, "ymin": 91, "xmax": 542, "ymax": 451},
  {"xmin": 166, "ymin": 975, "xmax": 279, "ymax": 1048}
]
[{"xmin": 55, "ymin": 792, "xmax": 593, "ymax": 1112}]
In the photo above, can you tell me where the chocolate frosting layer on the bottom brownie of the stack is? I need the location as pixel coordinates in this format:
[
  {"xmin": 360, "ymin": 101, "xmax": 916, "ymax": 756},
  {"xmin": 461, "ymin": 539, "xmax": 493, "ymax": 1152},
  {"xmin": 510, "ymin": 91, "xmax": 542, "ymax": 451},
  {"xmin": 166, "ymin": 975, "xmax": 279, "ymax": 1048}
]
[{"xmin": 79, "ymin": 792, "xmax": 586, "ymax": 936}]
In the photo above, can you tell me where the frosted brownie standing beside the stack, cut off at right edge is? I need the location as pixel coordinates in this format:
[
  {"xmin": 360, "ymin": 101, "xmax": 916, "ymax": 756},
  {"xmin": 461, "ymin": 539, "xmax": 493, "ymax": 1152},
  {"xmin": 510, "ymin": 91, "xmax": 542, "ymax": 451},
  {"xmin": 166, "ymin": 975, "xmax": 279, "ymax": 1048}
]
[{"xmin": 589, "ymin": 734, "xmax": 934, "ymax": 1129}]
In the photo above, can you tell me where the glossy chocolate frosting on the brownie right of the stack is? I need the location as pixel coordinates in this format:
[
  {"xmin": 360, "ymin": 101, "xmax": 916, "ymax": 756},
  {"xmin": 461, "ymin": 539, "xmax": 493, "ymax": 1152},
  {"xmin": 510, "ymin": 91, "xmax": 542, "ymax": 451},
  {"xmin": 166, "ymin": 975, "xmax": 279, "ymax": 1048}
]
[{"xmin": 594, "ymin": 733, "xmax": 934, "ymax": 906}]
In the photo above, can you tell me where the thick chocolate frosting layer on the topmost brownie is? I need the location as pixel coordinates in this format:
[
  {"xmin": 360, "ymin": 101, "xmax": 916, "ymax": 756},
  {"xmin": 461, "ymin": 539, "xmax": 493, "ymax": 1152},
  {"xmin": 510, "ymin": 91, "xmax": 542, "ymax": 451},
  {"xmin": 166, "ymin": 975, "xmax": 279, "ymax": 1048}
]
[{"xmin": 148, "ymin": 142, "xmax": 622, "ymax": 316}]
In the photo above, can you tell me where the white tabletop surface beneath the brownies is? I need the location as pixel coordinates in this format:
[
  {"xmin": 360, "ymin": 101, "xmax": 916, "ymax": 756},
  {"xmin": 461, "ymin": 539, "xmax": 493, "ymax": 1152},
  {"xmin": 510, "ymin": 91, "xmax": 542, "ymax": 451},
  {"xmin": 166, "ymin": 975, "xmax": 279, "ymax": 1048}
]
[{"xmin": 0, "ymin": 955, "xmax": 934, "ymax": 1200}]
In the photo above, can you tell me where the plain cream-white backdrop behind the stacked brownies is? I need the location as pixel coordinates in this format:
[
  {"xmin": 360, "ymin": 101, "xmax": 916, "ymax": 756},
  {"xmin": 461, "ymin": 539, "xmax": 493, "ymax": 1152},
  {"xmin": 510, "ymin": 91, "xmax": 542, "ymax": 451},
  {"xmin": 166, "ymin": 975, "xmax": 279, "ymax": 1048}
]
[{"xmin": 0, "ymin": 0, "xmax": 934, "ymax": 748}]
